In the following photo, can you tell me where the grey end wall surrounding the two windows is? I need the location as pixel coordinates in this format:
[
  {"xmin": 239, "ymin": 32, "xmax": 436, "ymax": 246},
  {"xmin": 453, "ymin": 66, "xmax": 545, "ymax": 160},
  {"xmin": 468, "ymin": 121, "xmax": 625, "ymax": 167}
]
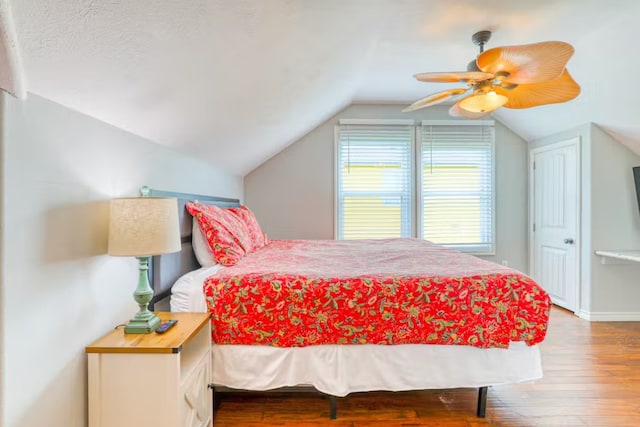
[{"xmin": 244, "ymin": 105, "xmax": 528, "ymax": 271}]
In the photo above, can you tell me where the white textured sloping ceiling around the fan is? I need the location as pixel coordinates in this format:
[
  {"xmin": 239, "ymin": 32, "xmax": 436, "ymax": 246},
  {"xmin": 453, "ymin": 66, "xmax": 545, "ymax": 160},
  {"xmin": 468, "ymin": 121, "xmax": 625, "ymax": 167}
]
[{"xmin": 5, "ymin": 0, "xmax": 640, "ymax": 175}]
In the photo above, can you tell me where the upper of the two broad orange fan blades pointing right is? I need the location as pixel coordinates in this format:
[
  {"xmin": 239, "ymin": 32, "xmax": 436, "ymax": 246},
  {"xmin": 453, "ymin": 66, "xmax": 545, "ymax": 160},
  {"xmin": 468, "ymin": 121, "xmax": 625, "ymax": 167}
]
[{"xmin": 476, "ymin": 41, "xmax": 574, "ymax": 84}]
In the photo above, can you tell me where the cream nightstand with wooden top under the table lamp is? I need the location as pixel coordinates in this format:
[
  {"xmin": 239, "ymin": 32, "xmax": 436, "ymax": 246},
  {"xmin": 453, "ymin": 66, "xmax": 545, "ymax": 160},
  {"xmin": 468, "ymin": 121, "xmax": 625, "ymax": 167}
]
[{"xmin": 86, "ymin": 313, "xmax": 213, "ymax": 427}]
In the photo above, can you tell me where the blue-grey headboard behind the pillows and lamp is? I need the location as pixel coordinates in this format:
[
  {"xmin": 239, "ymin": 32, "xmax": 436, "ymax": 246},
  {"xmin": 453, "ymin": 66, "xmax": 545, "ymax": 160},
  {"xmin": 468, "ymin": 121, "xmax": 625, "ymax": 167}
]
[{"xmin": 140, "ymin": 187, "xmax": 240, "ymax": 311}]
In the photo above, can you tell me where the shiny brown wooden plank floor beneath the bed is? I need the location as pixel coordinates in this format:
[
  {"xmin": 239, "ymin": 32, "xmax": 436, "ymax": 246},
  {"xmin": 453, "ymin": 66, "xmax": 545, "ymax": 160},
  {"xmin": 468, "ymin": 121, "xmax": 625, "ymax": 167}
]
[{"xmin": 214, "ymin": 308, "xmax": 640, "ymax": 427}]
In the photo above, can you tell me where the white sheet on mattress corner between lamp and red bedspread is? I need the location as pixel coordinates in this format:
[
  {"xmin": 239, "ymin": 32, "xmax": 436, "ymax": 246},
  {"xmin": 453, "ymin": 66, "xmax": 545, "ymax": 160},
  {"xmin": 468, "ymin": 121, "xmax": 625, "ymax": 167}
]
[{"xmin": 170, "ymin": 264, "xmax": 222, "ymax": 312}]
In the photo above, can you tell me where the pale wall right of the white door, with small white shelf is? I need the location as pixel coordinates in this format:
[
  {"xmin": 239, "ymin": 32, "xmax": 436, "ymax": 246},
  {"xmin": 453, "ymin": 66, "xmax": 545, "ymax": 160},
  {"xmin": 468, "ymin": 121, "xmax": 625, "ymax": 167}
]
[{"xmin": 531, "ymin": 124, "xmax": 640, "ymax": 320}]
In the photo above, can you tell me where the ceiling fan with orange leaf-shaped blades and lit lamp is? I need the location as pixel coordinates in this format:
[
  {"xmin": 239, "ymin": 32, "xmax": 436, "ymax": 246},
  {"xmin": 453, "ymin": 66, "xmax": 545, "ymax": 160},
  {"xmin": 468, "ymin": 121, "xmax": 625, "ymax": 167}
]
[{"xmin": 402, "ymin": 31, "xmax": 580, "ymax": 119}]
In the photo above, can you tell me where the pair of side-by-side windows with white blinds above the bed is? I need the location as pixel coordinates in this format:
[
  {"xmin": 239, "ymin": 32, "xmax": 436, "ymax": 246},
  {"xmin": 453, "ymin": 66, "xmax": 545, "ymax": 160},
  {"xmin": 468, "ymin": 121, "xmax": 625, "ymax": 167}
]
[{"xmin": 336, "ymin": 120, "xmax": 494, "ymax": 253}]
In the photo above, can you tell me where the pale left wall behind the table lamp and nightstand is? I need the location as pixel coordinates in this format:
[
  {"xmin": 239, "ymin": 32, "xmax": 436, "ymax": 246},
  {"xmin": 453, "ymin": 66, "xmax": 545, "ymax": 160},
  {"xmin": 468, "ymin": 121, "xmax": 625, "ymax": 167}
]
[{"xmin": 0, "ymin": 95, "xmax": 242, "ymax": 427}]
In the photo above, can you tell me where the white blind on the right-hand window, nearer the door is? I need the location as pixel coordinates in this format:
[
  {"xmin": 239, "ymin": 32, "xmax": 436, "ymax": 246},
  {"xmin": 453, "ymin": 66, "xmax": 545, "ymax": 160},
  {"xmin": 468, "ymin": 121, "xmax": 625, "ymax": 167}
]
[{"xmin": 418, "ymin": 123, "xmax": 495, "ymax": 253}]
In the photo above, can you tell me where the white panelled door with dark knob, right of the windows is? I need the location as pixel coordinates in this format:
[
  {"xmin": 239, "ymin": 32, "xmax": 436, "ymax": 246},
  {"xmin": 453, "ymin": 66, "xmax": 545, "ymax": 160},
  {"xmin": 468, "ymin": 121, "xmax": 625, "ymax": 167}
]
[{"xmin": 531, "ymin": 138, "xmax": 580, "ymax": 312}]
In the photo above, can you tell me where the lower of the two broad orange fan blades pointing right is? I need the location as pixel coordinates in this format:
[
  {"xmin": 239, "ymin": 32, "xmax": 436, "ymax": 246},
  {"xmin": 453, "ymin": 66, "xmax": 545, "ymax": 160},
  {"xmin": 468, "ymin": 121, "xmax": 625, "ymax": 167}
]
[{"xmin": 494, "ymin": 69, "xmax": 580, "ymax": 109}]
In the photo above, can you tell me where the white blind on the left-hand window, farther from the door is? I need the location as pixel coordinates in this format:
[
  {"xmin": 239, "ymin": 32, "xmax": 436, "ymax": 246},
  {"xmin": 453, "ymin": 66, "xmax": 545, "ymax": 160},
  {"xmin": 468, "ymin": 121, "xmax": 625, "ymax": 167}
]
[{"xmin": 336, "ymin": 125, "xmax": 414, "ymax": 239}]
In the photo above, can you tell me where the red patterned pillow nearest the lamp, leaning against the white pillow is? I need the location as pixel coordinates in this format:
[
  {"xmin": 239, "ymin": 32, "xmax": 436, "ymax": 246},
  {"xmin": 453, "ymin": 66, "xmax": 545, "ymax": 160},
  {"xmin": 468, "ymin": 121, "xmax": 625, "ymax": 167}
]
[{"xmin": 187, "ymin": 202, "xmax": 252, "ymax": 266}]
